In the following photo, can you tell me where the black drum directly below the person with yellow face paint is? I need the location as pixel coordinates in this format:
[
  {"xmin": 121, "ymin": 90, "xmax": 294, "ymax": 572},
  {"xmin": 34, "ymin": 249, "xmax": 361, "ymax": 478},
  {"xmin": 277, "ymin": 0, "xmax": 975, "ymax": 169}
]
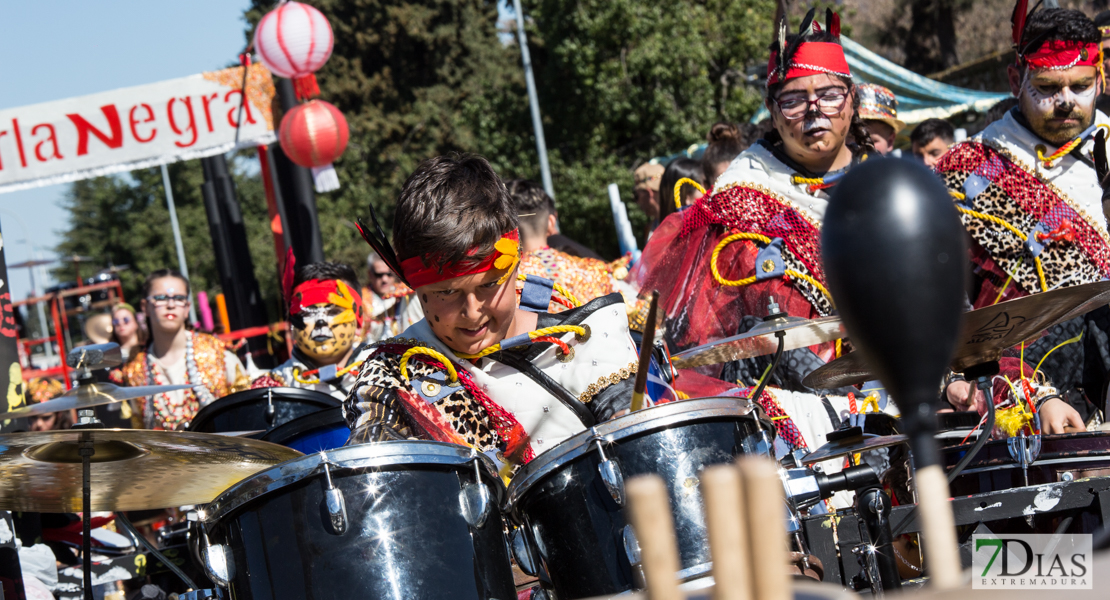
[{"xmin": 189, "ymin": 387, "xmax": 341, "ymax": 434}]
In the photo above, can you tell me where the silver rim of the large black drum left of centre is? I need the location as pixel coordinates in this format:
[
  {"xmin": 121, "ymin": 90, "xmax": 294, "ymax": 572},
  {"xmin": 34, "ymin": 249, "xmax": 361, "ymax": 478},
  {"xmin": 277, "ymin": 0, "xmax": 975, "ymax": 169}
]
[{"xmin": 202, "ymin": 439, "xmax": 504, "ymax": 523}]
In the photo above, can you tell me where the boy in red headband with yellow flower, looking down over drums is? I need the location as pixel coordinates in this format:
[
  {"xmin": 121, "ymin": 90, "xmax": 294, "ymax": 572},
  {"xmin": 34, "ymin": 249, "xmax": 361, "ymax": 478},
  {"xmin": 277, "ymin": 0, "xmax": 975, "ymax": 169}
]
[{"xmin": 344, "ymin": 150, "xmax": 636, "ymax": 464}]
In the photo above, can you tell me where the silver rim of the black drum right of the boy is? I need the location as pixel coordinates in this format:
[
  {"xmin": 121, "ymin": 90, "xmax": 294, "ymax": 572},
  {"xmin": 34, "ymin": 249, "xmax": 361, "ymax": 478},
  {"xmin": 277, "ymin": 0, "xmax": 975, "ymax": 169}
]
[{"xmin": 505, "ymin": 396, "xmax": 759, "ymax": 512}]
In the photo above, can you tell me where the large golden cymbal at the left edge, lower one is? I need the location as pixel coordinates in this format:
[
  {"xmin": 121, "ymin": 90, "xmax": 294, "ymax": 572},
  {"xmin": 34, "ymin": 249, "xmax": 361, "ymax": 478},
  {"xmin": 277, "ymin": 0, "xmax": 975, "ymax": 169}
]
[{"xmin": 0, "ymin": 429, "xmax": 302, "ymax": 512}]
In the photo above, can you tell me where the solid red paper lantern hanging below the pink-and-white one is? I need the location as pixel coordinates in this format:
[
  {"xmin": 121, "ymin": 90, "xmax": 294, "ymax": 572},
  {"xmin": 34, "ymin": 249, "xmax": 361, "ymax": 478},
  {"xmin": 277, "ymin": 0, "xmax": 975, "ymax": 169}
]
[{"xmin": 278, "ymin": 100, "xmax": 350, "ymax": 167}]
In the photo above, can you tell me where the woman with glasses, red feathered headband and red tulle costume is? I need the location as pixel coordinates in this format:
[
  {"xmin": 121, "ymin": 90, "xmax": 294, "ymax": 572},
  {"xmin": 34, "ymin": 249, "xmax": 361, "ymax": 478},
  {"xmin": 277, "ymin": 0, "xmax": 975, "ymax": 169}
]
[{"xmin": 633, "ymin": 10, "xmax": 892, "ymax": 470}]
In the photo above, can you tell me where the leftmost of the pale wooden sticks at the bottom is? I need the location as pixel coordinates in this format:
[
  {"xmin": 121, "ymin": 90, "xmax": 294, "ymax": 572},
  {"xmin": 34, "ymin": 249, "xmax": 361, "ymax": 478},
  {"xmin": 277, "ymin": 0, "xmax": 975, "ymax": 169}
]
[{"xmin": 625, "ymin": 475, "xmax": 683, "ymax": 600}]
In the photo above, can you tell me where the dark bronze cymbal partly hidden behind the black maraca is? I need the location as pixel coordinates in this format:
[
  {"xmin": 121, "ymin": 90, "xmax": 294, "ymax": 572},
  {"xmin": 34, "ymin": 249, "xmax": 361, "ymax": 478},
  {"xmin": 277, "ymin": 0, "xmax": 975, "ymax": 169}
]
[{"xmin": 801, "ymin": 282, "xmax": 1110, "ymax": 389}]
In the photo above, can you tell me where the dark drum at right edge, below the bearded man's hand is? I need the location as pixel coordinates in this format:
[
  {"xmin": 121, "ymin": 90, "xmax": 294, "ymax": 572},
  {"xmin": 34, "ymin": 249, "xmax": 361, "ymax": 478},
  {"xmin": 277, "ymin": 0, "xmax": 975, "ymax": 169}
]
[{"xmin": 941, "ymin": 431, "xmax": 1110, "ymax": 496}]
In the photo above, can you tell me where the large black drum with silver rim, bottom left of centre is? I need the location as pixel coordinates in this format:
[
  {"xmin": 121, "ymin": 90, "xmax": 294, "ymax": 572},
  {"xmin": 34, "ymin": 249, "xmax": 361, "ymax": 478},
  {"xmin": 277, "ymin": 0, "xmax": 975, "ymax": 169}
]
[{"xmin": 199, "ymin": 440, "xmax": 516, "ymax": 600}]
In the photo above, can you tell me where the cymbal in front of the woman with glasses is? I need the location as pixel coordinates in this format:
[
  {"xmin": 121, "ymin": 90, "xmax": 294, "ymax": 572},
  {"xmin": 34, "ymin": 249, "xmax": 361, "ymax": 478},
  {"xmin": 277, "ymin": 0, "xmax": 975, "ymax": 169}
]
[{"xmin": 672, "ymin": 317, "xmax": 847, "ymax": 368}]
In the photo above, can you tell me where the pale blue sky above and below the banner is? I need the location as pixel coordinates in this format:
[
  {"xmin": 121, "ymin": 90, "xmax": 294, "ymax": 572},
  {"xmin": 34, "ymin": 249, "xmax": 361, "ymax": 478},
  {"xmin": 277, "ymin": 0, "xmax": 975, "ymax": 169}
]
[{"xmin": 0, "ymin": 0, "xmax": 249, "ymax": 298}]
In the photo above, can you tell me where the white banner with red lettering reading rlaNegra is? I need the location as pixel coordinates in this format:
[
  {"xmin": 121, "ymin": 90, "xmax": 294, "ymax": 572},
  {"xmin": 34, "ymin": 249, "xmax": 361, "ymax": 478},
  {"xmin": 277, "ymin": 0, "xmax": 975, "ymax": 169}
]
[{"xmin": 0, "ymin": 64, "xmax": 276, "ymax": 193}]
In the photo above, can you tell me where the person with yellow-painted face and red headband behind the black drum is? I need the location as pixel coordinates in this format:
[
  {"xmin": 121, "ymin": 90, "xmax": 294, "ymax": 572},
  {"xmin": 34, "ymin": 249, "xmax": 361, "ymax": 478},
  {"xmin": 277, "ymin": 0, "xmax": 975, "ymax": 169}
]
[{"xmin": 251, "ymin": 263, "xmax": 370, "ymax": 400}]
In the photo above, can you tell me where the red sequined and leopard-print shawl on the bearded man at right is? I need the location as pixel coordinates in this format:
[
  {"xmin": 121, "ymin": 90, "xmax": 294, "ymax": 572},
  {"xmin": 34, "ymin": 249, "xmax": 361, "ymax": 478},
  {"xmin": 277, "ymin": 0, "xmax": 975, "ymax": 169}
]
[{"xmin": 937, "ymin": 143, "xmax": 1107, "ymax": 293}]
